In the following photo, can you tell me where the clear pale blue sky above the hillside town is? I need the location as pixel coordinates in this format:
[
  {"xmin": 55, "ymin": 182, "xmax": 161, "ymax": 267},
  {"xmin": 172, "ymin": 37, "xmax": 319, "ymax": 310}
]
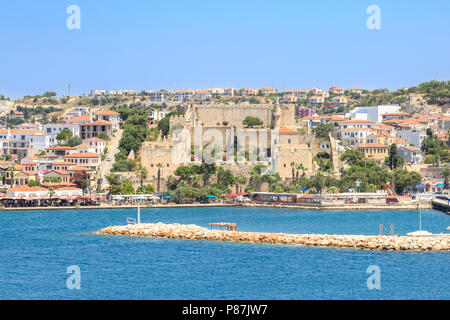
[{"xmin": 0, "ymin": 0, "xmax": 450, "ymax": 98}]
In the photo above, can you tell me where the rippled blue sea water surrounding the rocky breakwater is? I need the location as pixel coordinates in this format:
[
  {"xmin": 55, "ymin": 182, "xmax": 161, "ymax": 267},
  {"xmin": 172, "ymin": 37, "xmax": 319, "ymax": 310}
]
[{"xmin": 0, "ymin": 208, "xmax": 450, "ymax": 299}]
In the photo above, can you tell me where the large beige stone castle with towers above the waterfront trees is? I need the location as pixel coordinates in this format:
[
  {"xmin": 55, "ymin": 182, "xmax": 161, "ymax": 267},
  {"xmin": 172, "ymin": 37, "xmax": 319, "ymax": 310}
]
[{"xmin": 141, "ymin": 103, "xmax": 339, "ymax": 188}]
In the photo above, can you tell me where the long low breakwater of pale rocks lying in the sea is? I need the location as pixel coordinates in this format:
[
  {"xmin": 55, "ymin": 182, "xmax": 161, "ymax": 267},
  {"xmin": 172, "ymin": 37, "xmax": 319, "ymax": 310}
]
[{"xmin": 96, "ymin": 223, "xmax": 450, "ymax": 251}]
